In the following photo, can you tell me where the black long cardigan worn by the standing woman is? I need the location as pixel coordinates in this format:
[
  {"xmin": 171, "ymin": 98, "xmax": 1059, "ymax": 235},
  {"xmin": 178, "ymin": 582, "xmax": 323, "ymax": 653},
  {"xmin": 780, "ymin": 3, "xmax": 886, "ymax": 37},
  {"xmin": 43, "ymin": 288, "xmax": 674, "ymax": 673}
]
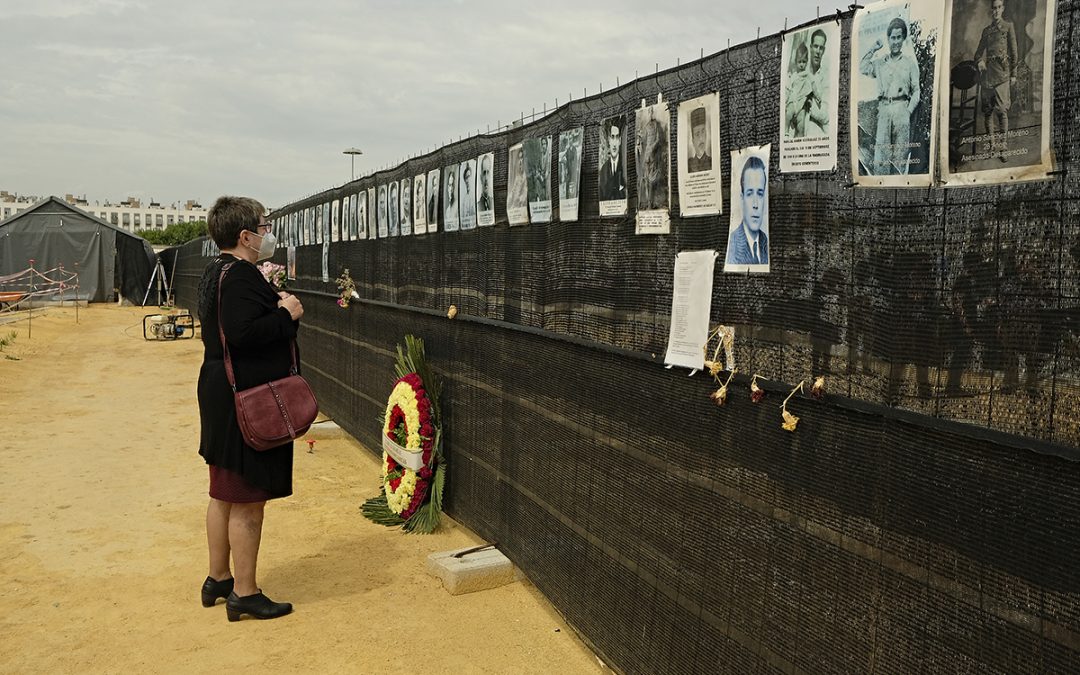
[{"xmin": 193, "ymin": 254, "xmax": 296, "ymax": 497}]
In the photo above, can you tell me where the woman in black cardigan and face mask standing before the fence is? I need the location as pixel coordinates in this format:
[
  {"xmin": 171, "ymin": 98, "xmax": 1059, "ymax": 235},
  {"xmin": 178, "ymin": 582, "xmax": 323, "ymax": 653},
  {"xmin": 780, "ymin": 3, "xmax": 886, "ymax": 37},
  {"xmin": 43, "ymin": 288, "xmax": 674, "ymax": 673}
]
[{"xmin": 199, "ymin": 197, "xmax": 303, "ymax": 621}]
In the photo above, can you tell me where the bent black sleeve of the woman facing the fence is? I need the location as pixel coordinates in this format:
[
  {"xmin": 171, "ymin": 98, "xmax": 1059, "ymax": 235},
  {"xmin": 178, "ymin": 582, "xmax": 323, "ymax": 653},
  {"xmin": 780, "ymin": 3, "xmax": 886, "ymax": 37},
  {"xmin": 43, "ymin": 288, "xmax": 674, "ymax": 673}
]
[{"xmin": 221, "ymin": 265, "xmax": 296, "ymax": 347}]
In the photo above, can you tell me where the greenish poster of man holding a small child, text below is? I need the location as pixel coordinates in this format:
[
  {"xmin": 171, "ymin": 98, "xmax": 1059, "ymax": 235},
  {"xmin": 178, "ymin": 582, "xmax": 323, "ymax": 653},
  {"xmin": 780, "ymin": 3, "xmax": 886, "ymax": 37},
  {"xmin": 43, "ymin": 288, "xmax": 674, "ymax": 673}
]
[{"xmin": 780, "ymin": 21, "xmax": 840, "ymax": 173}]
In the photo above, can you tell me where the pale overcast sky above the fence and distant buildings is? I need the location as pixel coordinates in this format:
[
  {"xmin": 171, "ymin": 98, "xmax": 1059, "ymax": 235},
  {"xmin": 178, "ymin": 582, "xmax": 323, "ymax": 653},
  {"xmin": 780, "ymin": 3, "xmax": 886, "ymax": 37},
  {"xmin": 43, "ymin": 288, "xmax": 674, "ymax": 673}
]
[{"xmin": 0, "ymin": 0, "xmax": 812, "ymax": 207}]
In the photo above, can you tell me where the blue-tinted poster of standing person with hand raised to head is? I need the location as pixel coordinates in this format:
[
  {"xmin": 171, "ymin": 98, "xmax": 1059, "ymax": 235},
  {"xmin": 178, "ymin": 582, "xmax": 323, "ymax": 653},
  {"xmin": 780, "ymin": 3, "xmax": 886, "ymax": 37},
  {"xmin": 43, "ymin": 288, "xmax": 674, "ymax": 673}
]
[{"xmin": 851, "ymin": 0, "xmax": 944, "ymax": 187}]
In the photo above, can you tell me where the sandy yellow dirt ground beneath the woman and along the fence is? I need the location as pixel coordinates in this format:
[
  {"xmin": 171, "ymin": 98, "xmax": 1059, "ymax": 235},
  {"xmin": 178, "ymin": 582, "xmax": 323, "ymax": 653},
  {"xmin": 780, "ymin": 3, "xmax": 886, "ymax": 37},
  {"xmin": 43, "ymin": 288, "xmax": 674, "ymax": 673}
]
[{"xmin": 0, "ymin": 305, "xmax": 606, "ymax": 673}]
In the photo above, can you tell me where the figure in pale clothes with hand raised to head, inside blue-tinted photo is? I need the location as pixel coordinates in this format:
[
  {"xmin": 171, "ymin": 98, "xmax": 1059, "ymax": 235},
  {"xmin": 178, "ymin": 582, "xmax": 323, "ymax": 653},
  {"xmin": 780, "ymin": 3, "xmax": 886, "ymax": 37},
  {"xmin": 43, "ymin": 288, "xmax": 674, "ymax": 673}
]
[{"xmin": 859, "ymin": 17, "xmax": 921, "ymax": 176}]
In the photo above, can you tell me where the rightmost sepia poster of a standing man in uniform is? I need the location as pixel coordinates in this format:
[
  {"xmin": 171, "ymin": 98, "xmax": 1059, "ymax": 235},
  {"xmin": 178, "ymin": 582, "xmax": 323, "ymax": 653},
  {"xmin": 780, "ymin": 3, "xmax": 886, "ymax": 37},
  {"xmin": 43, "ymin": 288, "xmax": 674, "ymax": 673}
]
[{"xmin": 940, "ymin": 0, "xmax": 1057, "ymax": 186}]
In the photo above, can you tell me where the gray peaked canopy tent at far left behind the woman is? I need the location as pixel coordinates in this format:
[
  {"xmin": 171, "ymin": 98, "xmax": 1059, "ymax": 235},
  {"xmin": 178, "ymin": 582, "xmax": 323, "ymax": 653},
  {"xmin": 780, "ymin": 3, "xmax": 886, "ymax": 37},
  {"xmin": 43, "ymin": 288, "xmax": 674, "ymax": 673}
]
[{"xmin": 0, "ymin": 197, "xmax": 157, "ymax": 305}]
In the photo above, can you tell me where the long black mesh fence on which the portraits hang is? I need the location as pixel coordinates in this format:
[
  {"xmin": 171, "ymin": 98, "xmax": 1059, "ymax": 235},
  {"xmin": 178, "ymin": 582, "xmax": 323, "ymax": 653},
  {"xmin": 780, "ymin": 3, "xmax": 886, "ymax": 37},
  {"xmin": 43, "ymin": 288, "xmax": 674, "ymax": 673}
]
[{"xmin": 176, "ymin": 6, "xmax": 1080, "ymax": 673}]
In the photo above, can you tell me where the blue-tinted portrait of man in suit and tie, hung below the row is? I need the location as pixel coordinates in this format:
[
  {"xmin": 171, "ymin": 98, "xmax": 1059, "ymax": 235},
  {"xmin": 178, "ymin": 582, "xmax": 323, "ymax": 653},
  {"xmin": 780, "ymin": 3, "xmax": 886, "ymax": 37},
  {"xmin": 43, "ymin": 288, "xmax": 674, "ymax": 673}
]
[{"xmin": 724, "ymin": 144, "xmax": 772, "ymax": 274}]
